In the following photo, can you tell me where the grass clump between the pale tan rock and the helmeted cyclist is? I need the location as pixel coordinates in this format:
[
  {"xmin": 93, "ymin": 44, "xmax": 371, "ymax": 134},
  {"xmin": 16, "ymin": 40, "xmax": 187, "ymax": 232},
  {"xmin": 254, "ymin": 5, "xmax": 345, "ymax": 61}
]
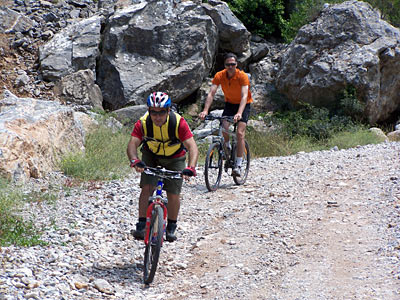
[{"xmin": 60, "ymin": 126, "xmax": 130, "ymax": 180}]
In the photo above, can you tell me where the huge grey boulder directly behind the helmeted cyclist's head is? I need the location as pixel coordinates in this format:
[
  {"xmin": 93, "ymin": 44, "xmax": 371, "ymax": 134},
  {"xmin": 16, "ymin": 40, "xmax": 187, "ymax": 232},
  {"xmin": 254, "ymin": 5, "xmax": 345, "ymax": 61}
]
[{"xmin": 97, "ymin": 0, "xmax": 218, "ymax": 110}]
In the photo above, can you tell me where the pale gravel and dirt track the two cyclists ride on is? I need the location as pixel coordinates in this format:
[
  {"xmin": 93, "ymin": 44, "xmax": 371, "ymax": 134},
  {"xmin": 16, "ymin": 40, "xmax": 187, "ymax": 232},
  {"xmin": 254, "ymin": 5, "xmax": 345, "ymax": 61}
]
[{"xmin": 0, "ymin": 143, "xmax": 400, "ymax": 300}]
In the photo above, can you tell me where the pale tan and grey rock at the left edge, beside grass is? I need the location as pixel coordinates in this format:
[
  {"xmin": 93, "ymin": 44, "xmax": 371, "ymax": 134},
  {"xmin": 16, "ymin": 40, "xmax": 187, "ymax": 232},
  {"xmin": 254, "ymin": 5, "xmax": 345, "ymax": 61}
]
[{"xmin": 0, "ymin": 91, "xmax": 91, "ymax": 180}]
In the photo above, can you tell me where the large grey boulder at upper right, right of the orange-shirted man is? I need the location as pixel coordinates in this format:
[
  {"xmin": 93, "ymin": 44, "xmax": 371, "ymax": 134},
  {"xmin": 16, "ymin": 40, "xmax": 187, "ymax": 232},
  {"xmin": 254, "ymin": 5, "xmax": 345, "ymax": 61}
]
[{"xmin": 275, "ymin": 1, "xmax": 400, "ymax": 124}]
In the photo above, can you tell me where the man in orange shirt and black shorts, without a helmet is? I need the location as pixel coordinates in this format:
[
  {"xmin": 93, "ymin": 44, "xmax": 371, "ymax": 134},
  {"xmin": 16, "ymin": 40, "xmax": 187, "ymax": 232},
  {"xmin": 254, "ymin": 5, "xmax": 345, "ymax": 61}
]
[{"xmin": 199, "ymin": 53, "xmax": 253, "ymax": 176}]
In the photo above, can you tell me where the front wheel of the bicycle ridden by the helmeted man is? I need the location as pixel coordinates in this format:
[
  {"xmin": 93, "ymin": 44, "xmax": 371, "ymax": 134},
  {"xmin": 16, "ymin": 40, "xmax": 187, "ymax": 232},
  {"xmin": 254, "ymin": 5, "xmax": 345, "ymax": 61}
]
[{"xmin": 143, "ymin": 206, "xmax": 164, "ymax": 284}]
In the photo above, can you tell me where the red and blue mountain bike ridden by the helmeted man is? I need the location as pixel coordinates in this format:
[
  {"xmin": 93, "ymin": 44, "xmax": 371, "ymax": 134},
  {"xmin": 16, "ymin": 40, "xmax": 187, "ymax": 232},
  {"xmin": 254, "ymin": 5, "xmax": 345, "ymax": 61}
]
[{"xmin": 143, "ymin": 166, "xmax": 182, "ymax": 284}]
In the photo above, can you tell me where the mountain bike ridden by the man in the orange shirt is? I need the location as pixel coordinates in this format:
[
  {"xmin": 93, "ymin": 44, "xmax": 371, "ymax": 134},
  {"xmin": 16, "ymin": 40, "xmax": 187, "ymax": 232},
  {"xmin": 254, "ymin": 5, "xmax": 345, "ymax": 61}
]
[{"xmin": 204, "ymin": 115, "xmax": 250, "ymax": 192}]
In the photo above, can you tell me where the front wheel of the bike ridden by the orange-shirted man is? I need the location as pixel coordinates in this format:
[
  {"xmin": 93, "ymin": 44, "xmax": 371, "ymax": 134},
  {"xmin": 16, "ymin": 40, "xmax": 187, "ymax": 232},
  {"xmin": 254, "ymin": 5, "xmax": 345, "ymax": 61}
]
[{"xmin": 204, "ymin": 142, "xmax": 223, "ymax": 192}]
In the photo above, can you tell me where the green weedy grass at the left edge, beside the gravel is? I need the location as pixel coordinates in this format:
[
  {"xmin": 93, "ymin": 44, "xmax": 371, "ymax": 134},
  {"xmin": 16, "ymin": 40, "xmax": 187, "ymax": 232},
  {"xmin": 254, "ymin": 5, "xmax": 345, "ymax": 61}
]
[{"xmin": 0, "ymin": 178, "xmax": 46, "ymax": 247}]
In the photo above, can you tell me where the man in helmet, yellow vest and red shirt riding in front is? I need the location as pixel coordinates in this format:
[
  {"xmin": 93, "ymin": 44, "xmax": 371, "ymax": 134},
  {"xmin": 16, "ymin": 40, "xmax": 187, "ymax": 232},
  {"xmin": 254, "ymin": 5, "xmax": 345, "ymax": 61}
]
[{"xmin": 127, "ymin": 92, "xmax": 199, "ymax": 242}]
